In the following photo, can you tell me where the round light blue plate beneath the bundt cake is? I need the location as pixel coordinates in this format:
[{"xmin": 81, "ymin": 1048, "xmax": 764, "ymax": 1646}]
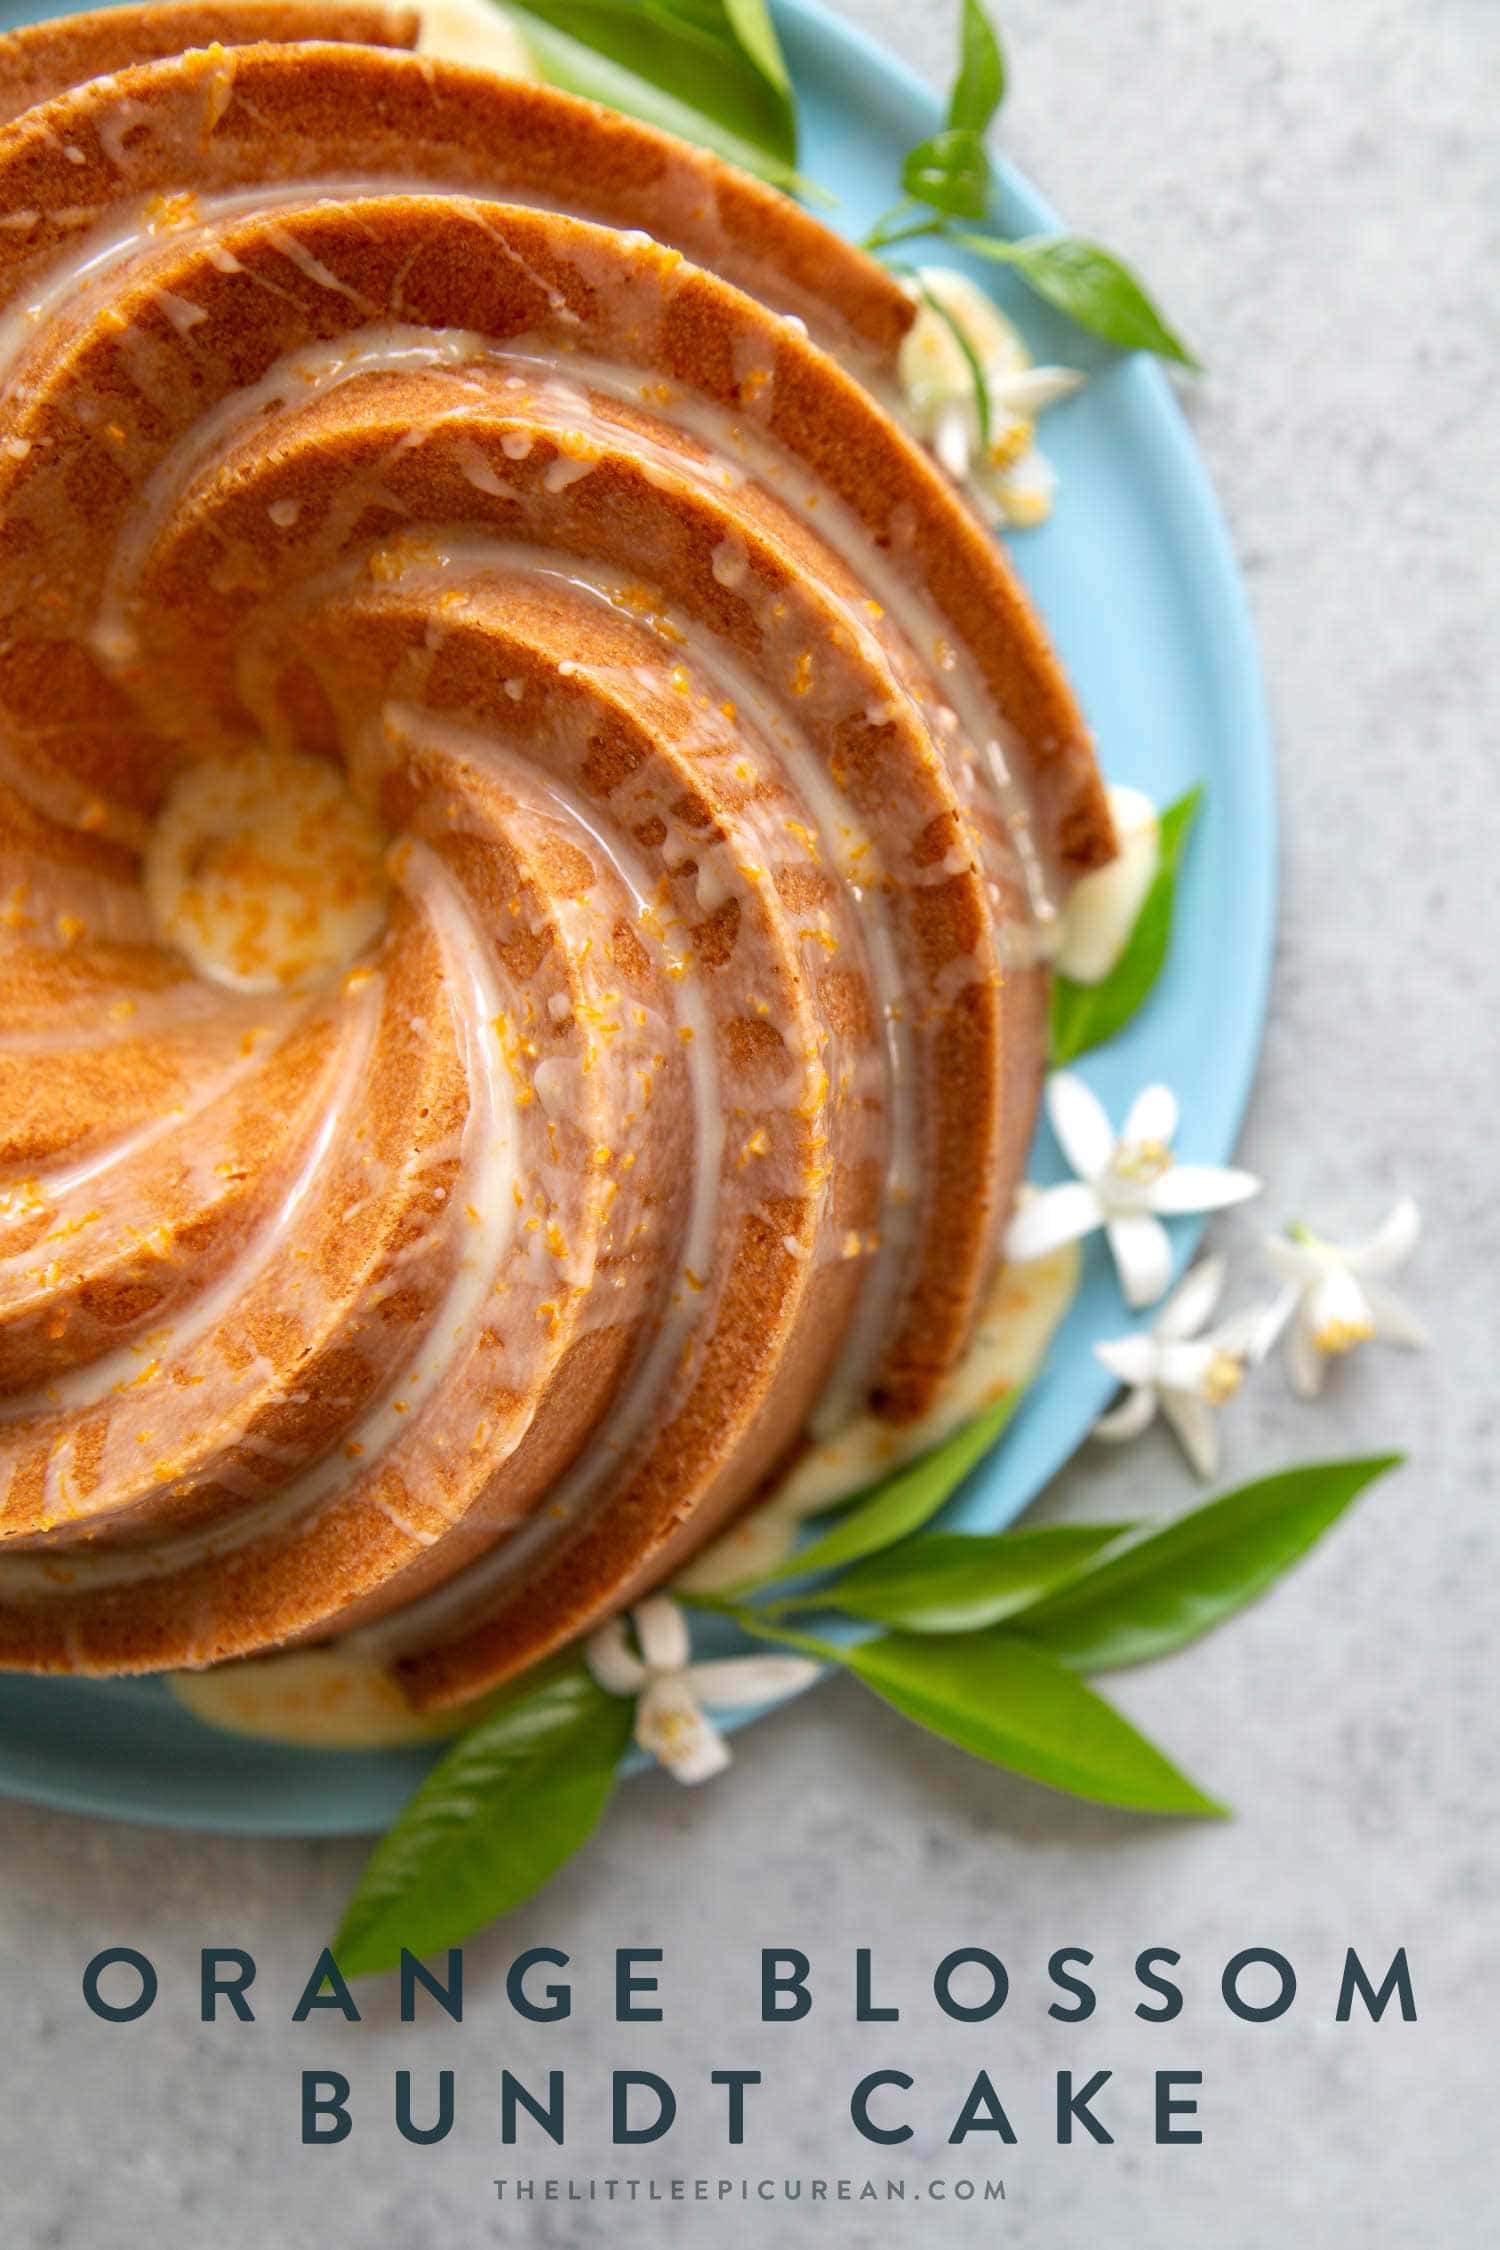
[{"xmin": 0, "ymin": 0, "xmax": 1275, "ymax": 1836}]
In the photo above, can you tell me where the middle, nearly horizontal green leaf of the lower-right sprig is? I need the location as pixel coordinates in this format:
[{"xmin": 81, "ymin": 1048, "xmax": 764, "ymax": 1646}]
[{"xmin": 791, "ymin": 1523, "xmax": 1133, "ymax": 1634}]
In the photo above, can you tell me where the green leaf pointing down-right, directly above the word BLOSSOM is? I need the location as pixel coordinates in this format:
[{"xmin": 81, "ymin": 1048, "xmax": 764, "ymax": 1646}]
[{"xmin": 841, "ymin": 1631, "xmax": 1223, "ymax": 1814}]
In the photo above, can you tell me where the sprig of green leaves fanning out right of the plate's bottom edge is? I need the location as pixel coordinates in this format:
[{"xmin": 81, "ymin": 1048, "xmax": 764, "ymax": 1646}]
[{"xmin": 697, "ymin": 1424, "xmax": 1401, "ymax": 1814}]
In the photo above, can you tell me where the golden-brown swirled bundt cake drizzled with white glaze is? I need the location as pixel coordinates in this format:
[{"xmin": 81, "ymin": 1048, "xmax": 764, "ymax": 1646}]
[{"xmin": 0, "ymin": 0, "xmax": 1111, "ymax": 1706}]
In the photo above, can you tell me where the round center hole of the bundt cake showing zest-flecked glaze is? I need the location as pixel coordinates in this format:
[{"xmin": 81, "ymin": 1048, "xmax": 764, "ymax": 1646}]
[{"xmin": 146, "ymin": 749, "xmax": 389, "ymax": 992}]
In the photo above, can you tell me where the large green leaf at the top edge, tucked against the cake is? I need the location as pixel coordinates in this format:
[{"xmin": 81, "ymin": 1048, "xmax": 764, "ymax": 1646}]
[{"xmin": 510, "ymin": 0, "xmax": 796, "ymax": 185}]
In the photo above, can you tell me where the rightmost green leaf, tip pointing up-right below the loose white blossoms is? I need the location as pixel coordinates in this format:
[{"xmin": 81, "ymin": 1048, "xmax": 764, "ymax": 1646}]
[{"xmin": 1010, "ymin": 1454, "xmax": 1403, "ymax": 1672}]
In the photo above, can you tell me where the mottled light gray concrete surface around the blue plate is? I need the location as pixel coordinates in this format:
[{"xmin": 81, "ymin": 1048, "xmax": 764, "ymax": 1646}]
[{"xmin": 0, "ymin": 0, "xmax": 1500, "ymax": 2250}]
